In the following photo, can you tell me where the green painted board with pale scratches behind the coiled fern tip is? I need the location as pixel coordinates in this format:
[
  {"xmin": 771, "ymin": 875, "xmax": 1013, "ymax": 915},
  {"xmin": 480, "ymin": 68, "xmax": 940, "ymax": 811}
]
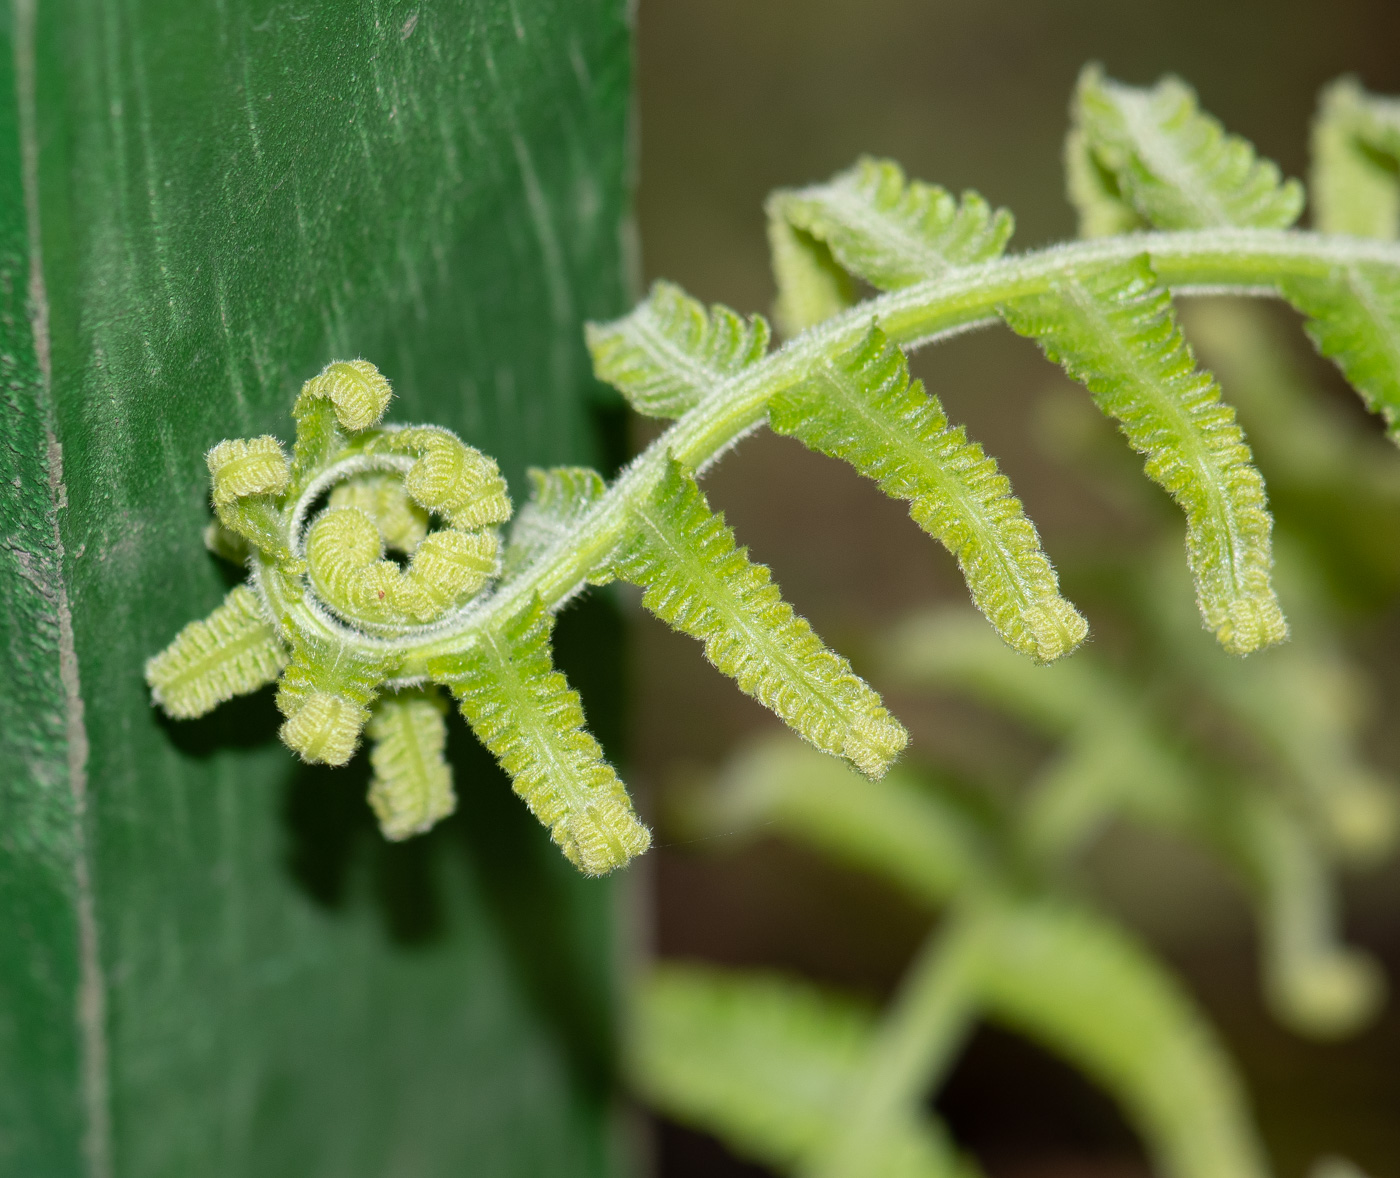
[{"xmin": 0, "ymin": 0, "xmax": 630, "ymax": 1178}]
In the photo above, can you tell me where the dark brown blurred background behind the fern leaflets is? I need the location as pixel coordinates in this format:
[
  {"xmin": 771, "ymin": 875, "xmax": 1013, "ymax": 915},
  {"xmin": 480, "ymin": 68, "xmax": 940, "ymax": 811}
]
[{"xmin": 630, "ymin": 0, "xmax": 1400, "ymax": 1178}]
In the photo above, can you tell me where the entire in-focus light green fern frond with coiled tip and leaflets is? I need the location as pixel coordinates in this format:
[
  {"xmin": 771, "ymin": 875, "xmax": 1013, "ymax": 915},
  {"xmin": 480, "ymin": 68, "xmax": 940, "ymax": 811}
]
[{"xmin": 147, "ymin": 69, "xmax": 1400, "ymax": 874}]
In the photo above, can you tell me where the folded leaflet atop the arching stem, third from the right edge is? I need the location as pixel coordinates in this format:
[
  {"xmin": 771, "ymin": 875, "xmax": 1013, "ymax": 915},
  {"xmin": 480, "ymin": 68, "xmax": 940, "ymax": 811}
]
[{"xmin": 767, "ymin": 158, "xmax": 1015, "ymax": 335}]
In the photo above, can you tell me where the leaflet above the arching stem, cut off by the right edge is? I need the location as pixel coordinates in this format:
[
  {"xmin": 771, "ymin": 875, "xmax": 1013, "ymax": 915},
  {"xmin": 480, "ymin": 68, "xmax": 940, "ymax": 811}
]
[{"xmin": 1309, "ymin": 77, "xmax": 1400, "ymax": 241}]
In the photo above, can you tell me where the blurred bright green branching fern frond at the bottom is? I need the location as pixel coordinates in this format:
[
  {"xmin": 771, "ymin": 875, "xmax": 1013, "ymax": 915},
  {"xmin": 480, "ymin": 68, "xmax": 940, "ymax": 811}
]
[{"xmin": 641, "ymin": 733, "xmax": 1267, "ymax": 1178}]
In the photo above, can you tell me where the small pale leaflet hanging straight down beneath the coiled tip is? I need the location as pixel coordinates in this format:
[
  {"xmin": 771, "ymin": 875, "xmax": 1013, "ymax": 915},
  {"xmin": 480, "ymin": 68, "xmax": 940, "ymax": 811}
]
[{"xmin": 364, "ymin": 688, "xmax": 456, "ymax": 842}]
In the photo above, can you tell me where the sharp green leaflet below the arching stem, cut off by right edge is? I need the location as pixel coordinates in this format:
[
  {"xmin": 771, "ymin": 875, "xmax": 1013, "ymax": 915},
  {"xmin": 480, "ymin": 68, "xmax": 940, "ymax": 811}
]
[{"xmin": 1281, "ymin": 262, "xmax": 1400, "ymax": 444}]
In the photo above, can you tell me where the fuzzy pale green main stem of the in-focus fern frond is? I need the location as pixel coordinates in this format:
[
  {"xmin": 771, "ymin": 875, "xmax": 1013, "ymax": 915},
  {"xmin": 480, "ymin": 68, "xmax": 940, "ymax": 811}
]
[{"xmin": 255, "ymin": 228, "xmax": 1400, "ymax": 681}]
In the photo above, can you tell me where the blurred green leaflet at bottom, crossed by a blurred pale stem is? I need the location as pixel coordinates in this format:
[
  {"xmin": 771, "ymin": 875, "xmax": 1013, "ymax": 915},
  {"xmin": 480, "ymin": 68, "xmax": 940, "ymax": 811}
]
[{"xmin": 630, "ymin": 965, "xmax": 976, "ymax": 1178}]
